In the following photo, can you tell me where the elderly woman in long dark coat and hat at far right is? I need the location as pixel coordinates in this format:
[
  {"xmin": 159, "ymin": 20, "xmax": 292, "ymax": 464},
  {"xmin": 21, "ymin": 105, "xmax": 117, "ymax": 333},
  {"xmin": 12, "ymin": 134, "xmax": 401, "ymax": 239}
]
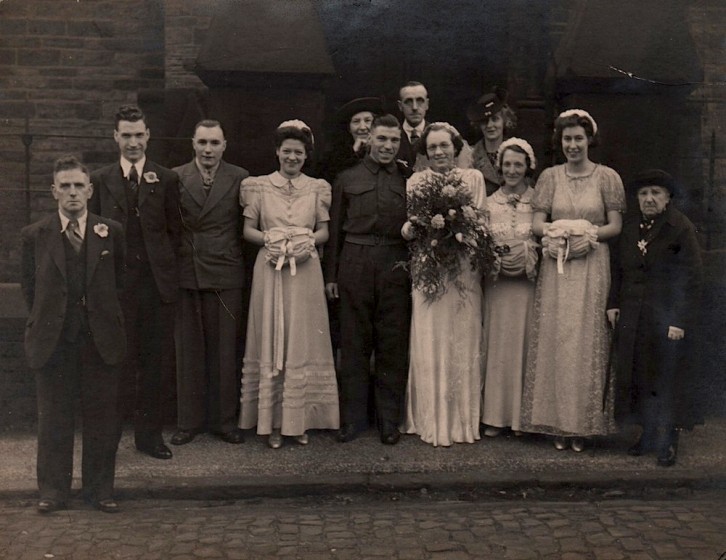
[{"xmin": 607, "ymin": 169, "xmax": 702, "ymax": 467}]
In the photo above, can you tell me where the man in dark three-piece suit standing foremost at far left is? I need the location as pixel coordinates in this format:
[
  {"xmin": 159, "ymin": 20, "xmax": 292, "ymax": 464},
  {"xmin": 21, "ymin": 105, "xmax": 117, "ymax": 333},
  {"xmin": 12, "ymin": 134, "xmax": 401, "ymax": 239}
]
[{"xmin": 21, "ymin": 157, "xmax": 126, "ymax": 513}]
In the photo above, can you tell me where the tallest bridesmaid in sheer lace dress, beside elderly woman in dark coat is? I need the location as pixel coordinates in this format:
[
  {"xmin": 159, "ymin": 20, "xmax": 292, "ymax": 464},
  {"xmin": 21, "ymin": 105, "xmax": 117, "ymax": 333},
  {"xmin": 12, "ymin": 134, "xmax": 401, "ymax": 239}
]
[{"xmin": 522, "ymin": 109, "xmax": 625, "ymax": 451}]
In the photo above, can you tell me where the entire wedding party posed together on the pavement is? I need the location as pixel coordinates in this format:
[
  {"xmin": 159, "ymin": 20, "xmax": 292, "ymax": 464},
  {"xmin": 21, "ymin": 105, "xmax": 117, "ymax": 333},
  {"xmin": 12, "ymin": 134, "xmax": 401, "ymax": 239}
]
[{"xmin": 22, "ymin": 82, "xmax": 701, "ymax": 513}]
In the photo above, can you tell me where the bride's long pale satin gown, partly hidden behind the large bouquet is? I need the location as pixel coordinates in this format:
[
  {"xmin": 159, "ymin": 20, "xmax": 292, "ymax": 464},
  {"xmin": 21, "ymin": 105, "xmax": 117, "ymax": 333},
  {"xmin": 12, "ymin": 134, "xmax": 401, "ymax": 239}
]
[{"xmin": 403, "ymin": 169, "xmax": 486, "ymax": 446}]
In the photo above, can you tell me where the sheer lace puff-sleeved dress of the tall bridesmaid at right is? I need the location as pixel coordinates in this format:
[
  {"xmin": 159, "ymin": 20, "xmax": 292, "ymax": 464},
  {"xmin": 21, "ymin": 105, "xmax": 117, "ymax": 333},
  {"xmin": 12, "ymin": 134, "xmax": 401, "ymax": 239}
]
[{"xmin": 522, "ymin": 165, "xmax": 625, "ymax": 437}]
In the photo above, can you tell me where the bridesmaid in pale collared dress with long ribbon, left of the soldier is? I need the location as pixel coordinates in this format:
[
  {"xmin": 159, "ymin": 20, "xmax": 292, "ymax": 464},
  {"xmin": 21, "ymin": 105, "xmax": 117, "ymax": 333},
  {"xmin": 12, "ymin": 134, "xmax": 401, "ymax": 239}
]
[{"xmin": 239, "ymin": 121, "xmax": 339, "ymax": 449}]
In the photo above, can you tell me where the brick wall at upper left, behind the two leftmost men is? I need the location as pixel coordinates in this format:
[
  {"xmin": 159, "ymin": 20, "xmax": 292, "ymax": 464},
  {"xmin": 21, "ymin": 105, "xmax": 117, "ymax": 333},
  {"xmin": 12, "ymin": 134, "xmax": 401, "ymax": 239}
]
[{"xmin": 0, "ymin": 0, "xmax": 164, "ymax": 282}]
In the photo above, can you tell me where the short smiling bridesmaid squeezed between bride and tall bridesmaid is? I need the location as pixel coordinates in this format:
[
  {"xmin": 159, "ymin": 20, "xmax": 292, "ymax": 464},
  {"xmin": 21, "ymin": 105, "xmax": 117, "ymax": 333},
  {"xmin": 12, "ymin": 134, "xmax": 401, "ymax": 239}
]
[{"xmin": 481, "ymin": 138, "xmax": 539, "ymax": 437}]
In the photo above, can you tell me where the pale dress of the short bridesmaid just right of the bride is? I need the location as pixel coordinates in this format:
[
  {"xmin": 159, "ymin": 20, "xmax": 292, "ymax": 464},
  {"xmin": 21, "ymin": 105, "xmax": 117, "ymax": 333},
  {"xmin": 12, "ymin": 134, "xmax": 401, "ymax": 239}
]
[{"xmin": 481, "ymin": 187, "xmax": 537, "ymax": 431}]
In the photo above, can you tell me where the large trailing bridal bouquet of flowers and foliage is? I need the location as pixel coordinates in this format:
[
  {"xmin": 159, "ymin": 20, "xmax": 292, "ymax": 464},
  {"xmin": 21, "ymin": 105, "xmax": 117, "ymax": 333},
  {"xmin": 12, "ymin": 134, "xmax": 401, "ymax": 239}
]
[{"xmin": 407, "ymin": 171, "xmax": 496, "ymax": 302}]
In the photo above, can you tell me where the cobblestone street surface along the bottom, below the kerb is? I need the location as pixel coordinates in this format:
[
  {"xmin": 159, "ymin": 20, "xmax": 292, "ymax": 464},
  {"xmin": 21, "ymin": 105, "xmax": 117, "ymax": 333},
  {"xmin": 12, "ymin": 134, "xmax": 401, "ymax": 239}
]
[{"xmin": 0, "ymin": 491, "xmax": 726, "ymax": 560}]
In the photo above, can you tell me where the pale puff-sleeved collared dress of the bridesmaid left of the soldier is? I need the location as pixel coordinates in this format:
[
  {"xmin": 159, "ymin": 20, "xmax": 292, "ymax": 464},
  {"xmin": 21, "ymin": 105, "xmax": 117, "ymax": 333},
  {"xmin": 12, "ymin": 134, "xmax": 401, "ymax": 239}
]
[{"xmin": 239, "ymin": 172, "xmax": 339, "ymax": 436}]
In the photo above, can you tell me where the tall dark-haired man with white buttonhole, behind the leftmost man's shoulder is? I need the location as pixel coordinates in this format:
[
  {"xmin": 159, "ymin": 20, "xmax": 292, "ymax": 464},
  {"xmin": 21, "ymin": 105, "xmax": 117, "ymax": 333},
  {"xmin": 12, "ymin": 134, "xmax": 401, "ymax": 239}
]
[{"xmin": 89, "ymin": 105, "xmax": 181, "ymax": 459}]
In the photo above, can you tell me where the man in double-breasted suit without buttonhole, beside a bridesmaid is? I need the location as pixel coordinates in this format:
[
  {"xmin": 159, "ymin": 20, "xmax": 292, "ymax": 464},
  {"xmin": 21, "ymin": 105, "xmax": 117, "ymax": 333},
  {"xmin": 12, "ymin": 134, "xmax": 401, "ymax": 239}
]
[{"xmin": 171, "ymin": 120, "xmax": 249, "ymax": 445}]
